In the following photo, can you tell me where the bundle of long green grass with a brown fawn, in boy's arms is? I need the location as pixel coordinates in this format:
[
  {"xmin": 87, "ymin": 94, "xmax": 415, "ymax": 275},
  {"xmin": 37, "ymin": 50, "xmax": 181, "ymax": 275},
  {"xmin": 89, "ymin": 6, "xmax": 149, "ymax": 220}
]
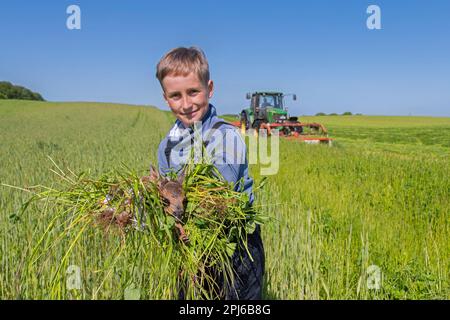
[{"xmin": 14, "ymin": 160, "xmax": 266, "ymax": 299}]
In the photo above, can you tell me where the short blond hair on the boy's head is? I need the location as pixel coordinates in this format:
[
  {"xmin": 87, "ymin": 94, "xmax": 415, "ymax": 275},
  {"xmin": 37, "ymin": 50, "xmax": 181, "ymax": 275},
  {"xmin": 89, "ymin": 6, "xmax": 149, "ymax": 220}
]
[{"xmin": 156, "ymin": 47, "xmax": 209, "ymax": 86}]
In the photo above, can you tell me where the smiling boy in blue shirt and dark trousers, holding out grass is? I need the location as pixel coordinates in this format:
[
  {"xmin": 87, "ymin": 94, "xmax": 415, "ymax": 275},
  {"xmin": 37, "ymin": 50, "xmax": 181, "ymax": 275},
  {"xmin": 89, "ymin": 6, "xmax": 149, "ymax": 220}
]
[{"xmin": 156, "ymin": 47, "xmax": 265, "ymax": 300}]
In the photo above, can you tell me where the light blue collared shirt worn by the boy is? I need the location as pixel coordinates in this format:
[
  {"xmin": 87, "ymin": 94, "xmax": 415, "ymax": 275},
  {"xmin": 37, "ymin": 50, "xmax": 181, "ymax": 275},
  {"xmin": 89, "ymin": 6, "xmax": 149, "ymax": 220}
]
[{"xmin": 158, "ymin": 104, "xmax": 254, "ymax": 204}]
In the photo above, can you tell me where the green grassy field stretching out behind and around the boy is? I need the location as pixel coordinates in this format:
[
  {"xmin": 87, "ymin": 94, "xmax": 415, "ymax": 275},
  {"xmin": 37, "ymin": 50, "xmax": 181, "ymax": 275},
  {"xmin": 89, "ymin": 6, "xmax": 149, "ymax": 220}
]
[{"xmin": 0, "ymin": 100, "xmax": 450, "ymax": 299}]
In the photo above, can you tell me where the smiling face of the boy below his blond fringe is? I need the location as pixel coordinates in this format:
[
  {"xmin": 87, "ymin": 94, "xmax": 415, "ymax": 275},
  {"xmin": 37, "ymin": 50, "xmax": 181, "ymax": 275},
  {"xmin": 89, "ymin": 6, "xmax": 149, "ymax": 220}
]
[{"xmin": 162, "ymin": 72, "xmax": 214, "ymax": 127}]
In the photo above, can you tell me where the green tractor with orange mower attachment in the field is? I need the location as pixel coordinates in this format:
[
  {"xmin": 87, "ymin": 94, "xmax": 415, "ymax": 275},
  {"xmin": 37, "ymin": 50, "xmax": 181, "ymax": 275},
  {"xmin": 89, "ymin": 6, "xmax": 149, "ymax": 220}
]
[{"xmin": 238, "ymin": 92, "xmax": 332, "ymax": 144}]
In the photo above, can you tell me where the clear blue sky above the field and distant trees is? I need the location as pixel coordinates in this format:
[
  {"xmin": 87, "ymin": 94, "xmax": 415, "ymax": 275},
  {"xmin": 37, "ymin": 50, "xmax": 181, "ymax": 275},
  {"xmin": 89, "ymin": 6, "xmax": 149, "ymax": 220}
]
[{"xmin": 0, "ymin": 0, "xmax": 450, "ymax": 116}]
